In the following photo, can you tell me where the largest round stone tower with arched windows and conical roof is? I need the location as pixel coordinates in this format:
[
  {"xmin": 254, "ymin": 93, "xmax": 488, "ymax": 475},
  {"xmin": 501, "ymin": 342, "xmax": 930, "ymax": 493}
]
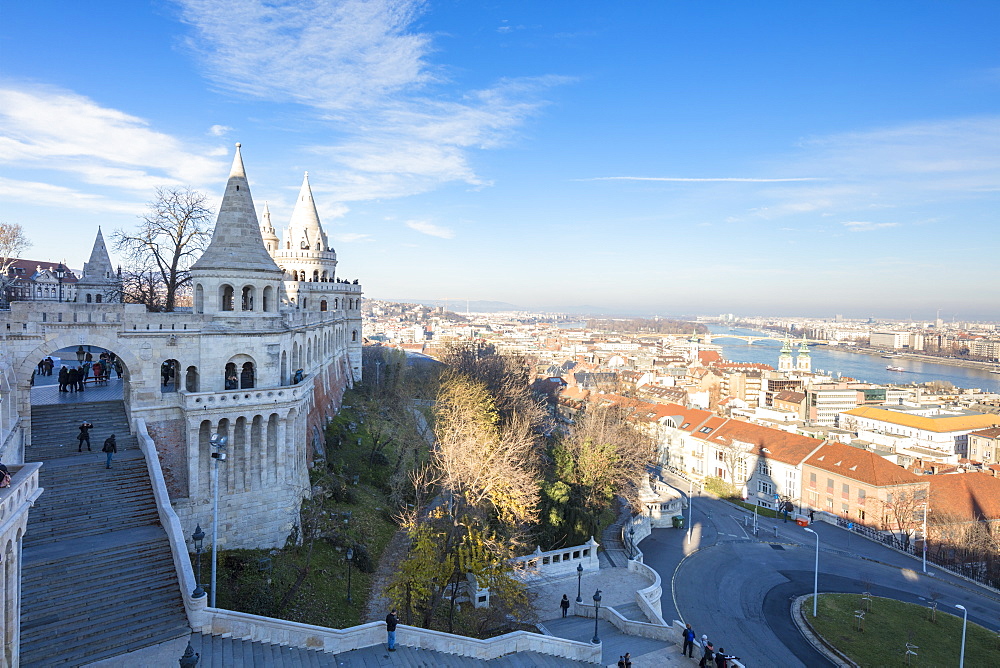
[{"xmin": 191, "ymin": 144, "xmax": 282, "ymax": 316}]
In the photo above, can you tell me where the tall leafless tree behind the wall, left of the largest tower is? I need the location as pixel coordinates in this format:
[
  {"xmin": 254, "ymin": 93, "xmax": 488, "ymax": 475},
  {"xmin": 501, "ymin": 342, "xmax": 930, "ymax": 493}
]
[{"xmin": 112, "ymin": 188, "xmax": 212, "ymax": 311}]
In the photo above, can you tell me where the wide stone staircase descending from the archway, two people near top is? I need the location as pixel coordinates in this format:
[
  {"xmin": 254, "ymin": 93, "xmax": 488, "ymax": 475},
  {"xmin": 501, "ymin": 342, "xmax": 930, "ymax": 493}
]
[{"xmin": 21, "ymin": 402, "xmax": 190, "ymax": 667}]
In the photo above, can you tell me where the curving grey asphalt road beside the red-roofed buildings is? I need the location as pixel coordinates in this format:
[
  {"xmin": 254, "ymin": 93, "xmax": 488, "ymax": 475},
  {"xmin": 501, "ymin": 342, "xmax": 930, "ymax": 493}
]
[{"xmin": 640, "ymin": 472, "xmax": 1000, "ymax": 668}]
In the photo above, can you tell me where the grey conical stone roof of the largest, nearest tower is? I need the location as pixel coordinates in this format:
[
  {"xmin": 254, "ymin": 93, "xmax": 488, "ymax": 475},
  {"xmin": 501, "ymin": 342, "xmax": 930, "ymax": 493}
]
[{"xmin": 191, "ymin": 144, "xmax": 281, "ymax": 275}]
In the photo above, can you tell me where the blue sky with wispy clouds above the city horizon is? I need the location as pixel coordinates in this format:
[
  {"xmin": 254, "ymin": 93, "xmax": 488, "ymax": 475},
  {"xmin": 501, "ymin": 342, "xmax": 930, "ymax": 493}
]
[{"xmin": 0, "ymin": 0, "xmax": 1000, "ymax": 319}]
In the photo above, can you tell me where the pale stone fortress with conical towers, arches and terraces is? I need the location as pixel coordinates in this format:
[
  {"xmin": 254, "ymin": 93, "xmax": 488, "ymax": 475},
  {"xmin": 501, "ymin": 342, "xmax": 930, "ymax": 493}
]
[{"xmin": 0, "ymin": 144, "xmax": 362, "ymax": 548}]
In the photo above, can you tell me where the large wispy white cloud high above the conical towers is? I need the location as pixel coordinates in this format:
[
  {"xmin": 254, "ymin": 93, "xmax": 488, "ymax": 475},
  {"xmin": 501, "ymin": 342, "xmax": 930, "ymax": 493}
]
[{"xmin": 177, "ymin": 0, "xmax": 566, "ymax": 200}]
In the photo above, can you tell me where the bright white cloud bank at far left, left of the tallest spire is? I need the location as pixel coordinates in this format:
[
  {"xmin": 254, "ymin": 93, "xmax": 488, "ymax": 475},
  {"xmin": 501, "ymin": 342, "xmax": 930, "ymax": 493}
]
[{"xmin": 0, "ymin": 85, "xmax": 225, "ymax": 194}]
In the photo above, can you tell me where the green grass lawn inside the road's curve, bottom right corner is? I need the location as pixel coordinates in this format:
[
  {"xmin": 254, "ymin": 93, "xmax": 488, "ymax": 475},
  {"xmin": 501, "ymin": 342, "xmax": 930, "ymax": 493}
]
[{"xmin": 802, "ymin": 594, "xmax": 1000, "ymax": 668}]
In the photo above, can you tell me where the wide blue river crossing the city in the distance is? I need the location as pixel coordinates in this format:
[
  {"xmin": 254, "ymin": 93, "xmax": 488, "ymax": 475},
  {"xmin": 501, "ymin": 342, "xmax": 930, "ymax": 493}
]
[{"xmin": 709, "ymin": 325, "xmax": 1000, "ymax": 392}]
